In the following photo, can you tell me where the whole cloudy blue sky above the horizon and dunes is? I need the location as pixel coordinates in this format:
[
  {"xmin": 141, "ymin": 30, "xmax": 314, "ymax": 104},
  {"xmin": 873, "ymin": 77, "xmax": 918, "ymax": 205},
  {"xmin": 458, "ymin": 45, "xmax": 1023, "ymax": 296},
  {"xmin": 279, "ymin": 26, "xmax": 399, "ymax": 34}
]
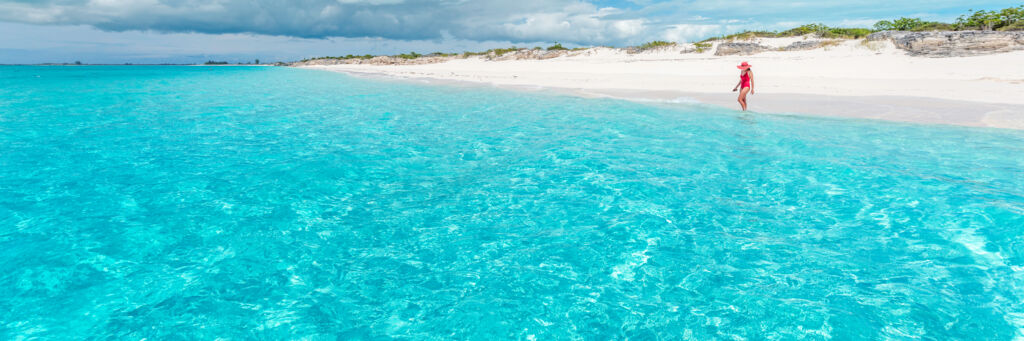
[{"xmin": 0, "ymin": 0, "xmax": 1021, "ymax": 63}]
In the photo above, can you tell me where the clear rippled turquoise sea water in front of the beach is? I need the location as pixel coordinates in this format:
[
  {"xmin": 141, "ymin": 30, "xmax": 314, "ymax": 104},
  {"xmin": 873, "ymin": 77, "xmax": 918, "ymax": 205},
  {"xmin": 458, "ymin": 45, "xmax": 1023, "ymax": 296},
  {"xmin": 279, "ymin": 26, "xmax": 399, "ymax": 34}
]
[{"xmin": 0, "ymin": 67, "xmax": 1024, "ymax": 340}]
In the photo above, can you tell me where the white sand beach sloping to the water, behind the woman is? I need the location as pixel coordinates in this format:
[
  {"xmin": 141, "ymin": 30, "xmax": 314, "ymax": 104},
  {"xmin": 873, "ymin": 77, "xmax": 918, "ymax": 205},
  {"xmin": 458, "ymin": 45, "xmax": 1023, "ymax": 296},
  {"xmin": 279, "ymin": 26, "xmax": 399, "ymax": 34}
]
[{"xmin": 303, "ymin": 37, "xmax": 1024, "ymax": 129}]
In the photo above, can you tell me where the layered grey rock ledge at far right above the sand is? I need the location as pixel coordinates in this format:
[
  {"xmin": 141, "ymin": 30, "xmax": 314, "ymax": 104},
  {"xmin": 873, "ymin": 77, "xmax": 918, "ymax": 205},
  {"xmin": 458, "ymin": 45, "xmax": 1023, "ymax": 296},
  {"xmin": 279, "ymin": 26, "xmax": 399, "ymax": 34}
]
[{"xmin": 867, "ymin": 31, "xmax": 1024, "ymax": 57}]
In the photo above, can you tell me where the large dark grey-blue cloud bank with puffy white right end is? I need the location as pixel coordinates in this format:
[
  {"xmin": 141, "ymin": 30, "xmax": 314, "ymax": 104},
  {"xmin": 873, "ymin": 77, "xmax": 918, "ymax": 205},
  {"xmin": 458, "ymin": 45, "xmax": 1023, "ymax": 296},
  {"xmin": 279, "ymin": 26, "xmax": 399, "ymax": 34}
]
[{"xmin": 0, "ymin": 0, "xmax": 645, "ymax": 44}]
